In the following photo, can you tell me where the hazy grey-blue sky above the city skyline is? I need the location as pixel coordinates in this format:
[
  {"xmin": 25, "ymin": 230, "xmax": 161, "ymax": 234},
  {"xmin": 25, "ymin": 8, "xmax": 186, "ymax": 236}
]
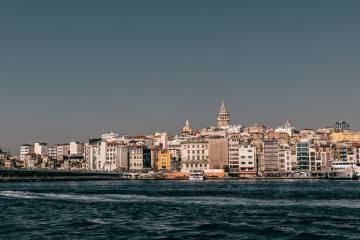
[{"xmin": 0, "ymin": 0, "xmax": 360, "ymax": 152}]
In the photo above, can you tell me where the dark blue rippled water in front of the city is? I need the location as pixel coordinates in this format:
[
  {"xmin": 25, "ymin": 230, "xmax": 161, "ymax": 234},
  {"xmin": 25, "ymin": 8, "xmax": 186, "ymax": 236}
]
[{"xmin": 0, "ymin": 180, "xmax": 360, "ymax": 239}]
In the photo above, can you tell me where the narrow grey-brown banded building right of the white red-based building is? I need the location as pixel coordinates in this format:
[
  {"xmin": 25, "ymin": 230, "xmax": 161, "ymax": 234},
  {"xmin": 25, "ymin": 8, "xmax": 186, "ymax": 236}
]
[{"xmin": 263, "ymin": 140, "xmax": 279, "ymax": 175}]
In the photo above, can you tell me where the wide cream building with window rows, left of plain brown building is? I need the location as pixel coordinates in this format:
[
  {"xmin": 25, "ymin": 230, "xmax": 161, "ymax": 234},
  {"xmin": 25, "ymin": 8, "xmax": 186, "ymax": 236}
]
[{"xmin": 181, "ymin": 139, "xmax": 210, "ymax": 171}]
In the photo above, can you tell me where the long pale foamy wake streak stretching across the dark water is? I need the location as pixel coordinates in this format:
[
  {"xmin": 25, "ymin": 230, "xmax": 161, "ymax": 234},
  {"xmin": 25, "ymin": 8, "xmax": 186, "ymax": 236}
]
[{"xmin": 0, "ymin": 191, "xmax": 360, "ymax": 208}]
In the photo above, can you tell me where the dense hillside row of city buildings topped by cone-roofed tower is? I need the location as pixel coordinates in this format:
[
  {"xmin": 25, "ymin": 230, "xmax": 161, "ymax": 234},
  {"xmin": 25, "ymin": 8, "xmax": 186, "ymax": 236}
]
[{"xmin": 0, "ymin": 102, "xmax": 360, "ymax": 177}]
